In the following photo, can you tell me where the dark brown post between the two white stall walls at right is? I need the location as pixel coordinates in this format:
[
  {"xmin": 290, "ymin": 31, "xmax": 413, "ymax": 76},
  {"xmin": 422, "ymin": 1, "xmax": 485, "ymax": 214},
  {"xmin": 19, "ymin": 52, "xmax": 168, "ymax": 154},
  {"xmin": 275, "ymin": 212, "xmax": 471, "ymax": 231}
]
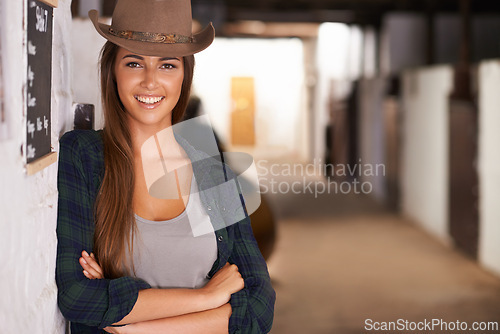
[{"xmin": 448, "ymin": 0, "xmax": 479, "ymax": 258}]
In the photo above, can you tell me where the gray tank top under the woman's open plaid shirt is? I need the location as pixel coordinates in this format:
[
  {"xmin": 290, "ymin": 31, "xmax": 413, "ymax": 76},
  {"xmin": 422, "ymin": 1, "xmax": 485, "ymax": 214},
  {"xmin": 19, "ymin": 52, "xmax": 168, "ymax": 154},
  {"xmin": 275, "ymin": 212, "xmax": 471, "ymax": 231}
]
[{"xmin": 132, "ymin": 177, "xmax": 217, "ymax": 289}]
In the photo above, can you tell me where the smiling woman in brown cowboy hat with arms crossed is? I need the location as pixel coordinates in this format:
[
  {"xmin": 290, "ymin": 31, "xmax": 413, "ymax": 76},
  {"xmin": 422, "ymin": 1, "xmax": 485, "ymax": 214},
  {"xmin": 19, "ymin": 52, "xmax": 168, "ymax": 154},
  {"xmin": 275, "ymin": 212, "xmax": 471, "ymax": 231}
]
[{"xmin": 56, "ymin": 0, "xmax": 275, "ymax": 333}]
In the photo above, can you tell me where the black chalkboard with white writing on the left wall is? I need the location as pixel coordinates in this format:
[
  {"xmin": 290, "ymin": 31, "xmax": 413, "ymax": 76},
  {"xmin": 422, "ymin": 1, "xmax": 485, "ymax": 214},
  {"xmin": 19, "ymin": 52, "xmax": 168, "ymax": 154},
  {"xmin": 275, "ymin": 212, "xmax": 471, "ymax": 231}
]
[{"xmin": 26, "ymin": 0, "xmax": 53, "ymax": 163}]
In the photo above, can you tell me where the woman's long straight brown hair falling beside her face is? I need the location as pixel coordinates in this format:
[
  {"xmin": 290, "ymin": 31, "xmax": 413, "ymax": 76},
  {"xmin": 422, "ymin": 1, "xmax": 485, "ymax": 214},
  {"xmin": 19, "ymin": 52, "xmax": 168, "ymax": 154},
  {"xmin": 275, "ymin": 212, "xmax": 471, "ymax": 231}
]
[{"xmin": 94, "ymin": 42, "xmax": 194, "ymax": 278}]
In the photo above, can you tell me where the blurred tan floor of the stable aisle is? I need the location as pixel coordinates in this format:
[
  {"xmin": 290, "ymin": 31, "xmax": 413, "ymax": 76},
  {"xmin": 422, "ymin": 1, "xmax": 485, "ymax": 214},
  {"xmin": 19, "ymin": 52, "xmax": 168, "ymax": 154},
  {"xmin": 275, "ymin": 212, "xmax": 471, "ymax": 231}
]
[{"xmin": 267, "ymin": 170, "xmax": 500, "ymax": 334}]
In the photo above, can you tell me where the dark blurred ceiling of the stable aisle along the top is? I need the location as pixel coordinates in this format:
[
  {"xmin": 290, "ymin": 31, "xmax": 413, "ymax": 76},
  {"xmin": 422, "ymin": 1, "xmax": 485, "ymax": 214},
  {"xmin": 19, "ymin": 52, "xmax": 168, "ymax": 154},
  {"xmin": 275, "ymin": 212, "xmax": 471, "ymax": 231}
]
[{"xmin": 192, "ymin": 0, "xmax": 500, "ymax": 25}]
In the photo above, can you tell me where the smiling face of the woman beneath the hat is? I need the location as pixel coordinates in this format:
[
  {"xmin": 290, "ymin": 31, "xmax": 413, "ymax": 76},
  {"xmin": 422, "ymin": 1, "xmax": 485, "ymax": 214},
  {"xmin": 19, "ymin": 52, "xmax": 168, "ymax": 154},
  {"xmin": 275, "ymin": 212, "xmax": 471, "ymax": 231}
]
[{"xmin": 114, "ymin": 48, "xmax": 184, "ymax": 132}]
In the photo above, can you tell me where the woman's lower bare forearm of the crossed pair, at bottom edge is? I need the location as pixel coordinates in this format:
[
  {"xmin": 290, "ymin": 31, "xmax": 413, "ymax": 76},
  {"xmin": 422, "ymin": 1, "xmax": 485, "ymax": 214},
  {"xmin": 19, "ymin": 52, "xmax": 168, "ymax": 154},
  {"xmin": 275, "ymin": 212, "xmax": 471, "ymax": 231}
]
[{"xmin": 120, "ymin": 303, "xmax": 231, "ymax": 334}]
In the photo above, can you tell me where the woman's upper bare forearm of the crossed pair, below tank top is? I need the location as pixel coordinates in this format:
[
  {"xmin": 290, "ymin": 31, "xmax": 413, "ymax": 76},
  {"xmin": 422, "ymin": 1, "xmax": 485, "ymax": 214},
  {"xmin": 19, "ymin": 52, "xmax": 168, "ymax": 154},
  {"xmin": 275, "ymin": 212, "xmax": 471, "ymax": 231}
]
[{"xmin": 114, "ymin": 289, "xmax": 215, "ymax": 325}]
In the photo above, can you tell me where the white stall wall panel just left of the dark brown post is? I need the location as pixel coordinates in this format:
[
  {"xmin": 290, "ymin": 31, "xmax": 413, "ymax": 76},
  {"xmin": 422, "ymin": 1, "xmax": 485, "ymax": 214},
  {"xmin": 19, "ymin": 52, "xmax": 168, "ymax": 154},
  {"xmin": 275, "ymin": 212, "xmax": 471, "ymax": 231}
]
[{"xmin": 401, "ymin": 66, "xmax": 452, "ymax": 242}]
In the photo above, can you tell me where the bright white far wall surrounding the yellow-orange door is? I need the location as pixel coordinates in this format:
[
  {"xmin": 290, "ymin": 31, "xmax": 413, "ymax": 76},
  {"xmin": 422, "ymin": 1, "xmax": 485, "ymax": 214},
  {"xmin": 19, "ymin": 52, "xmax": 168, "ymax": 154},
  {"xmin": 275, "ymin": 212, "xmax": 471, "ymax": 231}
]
[{"xmin": 193, "ymin": 38, "xmax": 306, "ymax": 160}]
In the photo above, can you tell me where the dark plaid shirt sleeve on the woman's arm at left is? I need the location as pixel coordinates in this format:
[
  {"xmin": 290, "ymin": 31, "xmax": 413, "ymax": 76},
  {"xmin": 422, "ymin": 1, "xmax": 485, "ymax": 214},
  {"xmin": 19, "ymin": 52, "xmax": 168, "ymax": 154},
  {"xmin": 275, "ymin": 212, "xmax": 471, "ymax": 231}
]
[{"xmin": 56, "ymin": 131, "xmax": 150, "ymax": 328}]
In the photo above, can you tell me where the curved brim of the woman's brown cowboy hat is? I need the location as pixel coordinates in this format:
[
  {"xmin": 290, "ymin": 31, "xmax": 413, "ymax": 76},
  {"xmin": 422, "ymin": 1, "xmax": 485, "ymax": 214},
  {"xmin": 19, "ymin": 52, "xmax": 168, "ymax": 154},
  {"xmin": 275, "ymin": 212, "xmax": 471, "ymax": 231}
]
[{"xmin": 89, "ymin": 9, "xmax": 215, "ymax": 57}]
